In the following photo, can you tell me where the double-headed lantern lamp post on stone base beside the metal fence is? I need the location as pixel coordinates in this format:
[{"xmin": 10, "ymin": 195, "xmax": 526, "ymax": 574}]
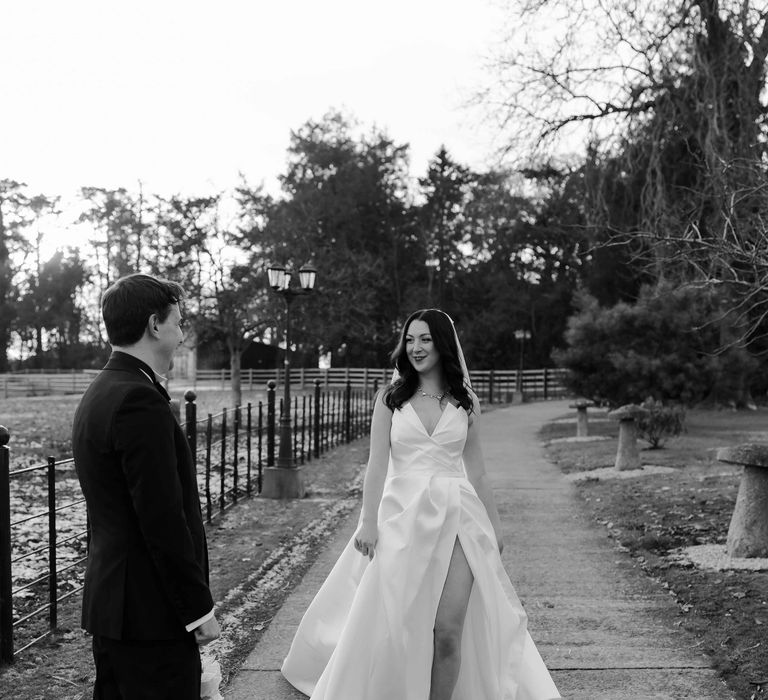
[{"xmin": 261, "ymin": 264, "xmax": 317, "ymax": 498}]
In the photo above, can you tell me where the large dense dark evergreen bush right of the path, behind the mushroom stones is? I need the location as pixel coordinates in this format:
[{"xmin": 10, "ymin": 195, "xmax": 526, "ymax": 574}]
[{"xmin": 553, "ymin": 286, "xmax": 744, "ymax": 406}]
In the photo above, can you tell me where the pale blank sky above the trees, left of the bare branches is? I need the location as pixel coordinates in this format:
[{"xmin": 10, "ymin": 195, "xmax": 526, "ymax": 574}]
[{"xmin": 0, "ymin": 0, "xmax": 502, "ymax": 223}]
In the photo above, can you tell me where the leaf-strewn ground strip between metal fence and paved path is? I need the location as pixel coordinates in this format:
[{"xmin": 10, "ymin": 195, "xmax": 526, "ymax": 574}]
[{"xmin": 0, "ymin": 439, "xmax": 368, "ymax": 700}]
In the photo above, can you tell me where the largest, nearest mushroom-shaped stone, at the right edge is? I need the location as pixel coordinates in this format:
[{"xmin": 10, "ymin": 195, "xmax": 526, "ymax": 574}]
[{"xmin": 717, "ymin": 443, "xmax": 768, "ymax": 558}]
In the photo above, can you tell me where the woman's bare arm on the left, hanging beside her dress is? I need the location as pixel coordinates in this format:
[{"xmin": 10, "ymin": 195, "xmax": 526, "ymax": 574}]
[{"xmin": 355, "ymin": 392, "xmax": 392, "ymax": 559}]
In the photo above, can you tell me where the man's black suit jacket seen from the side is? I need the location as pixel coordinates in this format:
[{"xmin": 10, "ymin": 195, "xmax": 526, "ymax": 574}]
[{"xmin": 72, "ymin": 352, "xmax": 213, "ymax": 640}]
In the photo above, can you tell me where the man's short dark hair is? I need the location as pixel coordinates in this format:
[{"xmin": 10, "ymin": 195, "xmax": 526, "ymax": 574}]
[{"xmin": 101, "ymin": 272, "xmax": 184, "ymax": 346}]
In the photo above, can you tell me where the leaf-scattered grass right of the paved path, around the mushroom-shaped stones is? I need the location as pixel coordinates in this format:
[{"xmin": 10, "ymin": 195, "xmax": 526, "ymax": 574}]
[{"xmin": 540, "ymin": 409, "xmax": 768, "ymax": 700}]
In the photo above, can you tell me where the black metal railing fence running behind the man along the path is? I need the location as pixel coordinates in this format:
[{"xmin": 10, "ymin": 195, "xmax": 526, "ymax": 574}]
[{"xmin": 0, "ymin": 381, "xmax": 374, "ymax": 663}]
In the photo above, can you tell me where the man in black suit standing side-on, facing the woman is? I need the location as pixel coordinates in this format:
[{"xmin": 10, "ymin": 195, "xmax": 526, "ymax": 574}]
[{"xmin": 72, "ymin": 274, "xmax": 219, "ymax": 700}]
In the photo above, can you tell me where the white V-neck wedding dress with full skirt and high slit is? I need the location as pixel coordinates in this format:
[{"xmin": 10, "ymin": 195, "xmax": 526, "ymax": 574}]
[{"xmin": 281, "ymin": 403, "xmax": 560, "ymax": 700}]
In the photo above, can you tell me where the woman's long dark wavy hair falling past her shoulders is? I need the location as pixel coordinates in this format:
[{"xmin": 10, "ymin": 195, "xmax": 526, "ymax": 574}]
[{"xmin": 384, "ymin": 309, "xmax": 473, "ymax": 413}]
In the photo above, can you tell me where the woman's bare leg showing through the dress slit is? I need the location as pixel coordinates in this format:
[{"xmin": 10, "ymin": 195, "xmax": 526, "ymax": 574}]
[{"xmin": 429, "ymin": 537, "xmax": 474, "ymax": 700}]
